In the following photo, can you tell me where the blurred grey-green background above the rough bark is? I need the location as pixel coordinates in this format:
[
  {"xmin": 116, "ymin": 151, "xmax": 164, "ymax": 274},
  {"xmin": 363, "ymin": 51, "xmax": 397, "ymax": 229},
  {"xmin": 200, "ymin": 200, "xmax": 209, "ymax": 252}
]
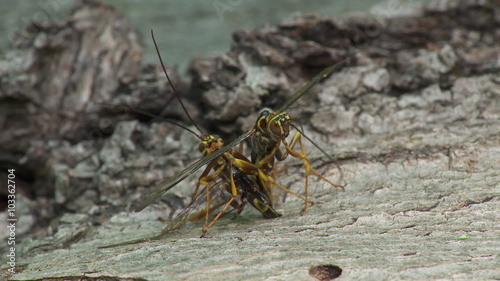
[{"xmin": 0, "ymin": 0, "xmax": 430, "ymax": 73}]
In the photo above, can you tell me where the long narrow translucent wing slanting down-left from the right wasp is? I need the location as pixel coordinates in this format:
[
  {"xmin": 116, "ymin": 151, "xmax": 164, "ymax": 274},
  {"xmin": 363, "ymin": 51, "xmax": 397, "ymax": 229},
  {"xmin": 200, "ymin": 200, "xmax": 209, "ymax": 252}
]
[{"xmin": 135, "ymin": 130, "xmax": 254, "ymax": 212}]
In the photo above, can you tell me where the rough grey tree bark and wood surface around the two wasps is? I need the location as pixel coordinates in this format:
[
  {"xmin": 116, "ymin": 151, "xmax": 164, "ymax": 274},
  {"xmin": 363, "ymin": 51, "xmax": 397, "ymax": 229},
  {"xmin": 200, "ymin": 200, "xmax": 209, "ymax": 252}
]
[{"xmin": 0, "ymin": 0, "xmax": 500, "ymax": 280}]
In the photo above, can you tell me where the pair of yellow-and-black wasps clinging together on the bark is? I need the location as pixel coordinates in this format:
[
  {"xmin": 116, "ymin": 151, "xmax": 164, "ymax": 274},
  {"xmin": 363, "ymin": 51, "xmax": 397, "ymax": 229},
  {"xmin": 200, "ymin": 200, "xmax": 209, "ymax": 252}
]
[{"xmin": 109, "ymin": 31, "xmax": 352, "ymax": 243}]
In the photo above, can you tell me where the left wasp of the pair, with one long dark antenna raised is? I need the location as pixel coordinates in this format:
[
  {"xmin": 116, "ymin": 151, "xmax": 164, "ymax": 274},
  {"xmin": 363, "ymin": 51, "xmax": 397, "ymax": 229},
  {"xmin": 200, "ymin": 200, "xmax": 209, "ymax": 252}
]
[{"xmin": 135, "ymin": 31, "xmax": 281, "ymax": 236}]
